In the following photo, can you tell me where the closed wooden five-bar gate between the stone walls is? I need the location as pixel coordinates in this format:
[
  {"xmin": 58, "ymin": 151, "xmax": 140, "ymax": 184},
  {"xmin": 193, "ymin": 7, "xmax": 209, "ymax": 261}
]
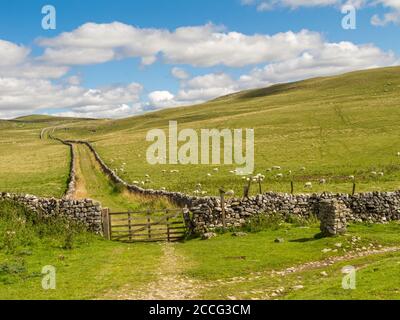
[{"xmin": 103, "ymin": 209, "xmax": 187, "ymax": 242}]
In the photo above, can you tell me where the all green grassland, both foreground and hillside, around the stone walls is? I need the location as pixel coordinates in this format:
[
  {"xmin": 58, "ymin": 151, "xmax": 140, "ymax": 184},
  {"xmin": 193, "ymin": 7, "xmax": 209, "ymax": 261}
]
[{"xmin": 0, "ymin": 68, "xmax": 400, "ymax": 299}]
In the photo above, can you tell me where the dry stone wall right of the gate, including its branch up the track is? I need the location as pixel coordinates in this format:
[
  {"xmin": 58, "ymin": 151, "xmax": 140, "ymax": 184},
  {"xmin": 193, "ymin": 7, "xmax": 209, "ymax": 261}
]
[{"xmin": 53, "ymin": 134, "xmax": 400, "ymax": 233}]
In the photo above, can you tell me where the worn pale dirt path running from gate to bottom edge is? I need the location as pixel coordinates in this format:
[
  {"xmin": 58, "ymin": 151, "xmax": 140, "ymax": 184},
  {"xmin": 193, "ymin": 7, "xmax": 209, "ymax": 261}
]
[{"xmin": 106, "ymin": 243, "xmax": 209, "ymax": 300}]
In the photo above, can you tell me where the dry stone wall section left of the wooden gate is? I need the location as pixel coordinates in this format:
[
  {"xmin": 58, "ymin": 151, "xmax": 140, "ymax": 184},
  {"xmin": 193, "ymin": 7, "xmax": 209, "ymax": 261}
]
[{"xmin": 0, "ymin": 193, "xmax": 102, "ymax": 234}]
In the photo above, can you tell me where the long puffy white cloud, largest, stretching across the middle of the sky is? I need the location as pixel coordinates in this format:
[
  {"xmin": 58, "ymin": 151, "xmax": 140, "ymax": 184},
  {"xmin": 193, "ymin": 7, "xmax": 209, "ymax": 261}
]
[{"xmin": 38, "ymin": 22, "xmax": 321, "ymax": 67}]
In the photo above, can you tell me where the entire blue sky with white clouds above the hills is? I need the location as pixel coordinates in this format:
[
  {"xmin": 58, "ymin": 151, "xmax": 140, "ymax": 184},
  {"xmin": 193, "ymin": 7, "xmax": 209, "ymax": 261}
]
[{"xmin": 0, "ymin": 0, "xmax": 400, "ymax": 118}]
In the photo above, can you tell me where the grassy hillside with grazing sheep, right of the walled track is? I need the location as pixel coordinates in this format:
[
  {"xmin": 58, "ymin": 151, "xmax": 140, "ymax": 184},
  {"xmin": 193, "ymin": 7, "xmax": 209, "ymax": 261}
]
[{"xmin": 52, "ymin": 67, "xmax": 400, "ymax": 194}]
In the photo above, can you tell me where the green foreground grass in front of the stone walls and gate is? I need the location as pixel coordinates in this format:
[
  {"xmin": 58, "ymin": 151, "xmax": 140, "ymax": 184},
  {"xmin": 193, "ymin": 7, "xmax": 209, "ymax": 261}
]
[{"xmin": 0, "ymin": 202, "xmax": 400, "ymax": 299}]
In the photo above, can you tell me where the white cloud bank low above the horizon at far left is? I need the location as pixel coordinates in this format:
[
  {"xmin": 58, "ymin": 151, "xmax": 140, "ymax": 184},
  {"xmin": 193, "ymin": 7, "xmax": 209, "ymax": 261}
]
[{"xmin": 0, "ymin": 77, "xmax": 142, "ymax": 118}]
